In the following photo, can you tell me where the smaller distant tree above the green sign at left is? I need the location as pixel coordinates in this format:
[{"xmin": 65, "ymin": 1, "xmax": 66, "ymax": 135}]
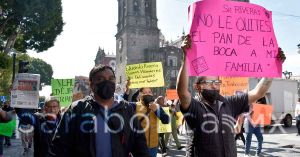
[{"xmin": 28, "ymin": 58, "xmax": 53, "ymax": 85}]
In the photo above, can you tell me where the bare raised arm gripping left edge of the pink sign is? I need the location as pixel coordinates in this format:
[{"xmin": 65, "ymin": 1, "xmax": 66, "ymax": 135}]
[{"xmin": 176, "ymin": 35, "xmax": 191, "ymax": 110}]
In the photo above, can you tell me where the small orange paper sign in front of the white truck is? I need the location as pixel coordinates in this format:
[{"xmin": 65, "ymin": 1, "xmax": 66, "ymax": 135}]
[{"xmin": 251, "ymin": 104, "xmax": 273, "ymax": 125}]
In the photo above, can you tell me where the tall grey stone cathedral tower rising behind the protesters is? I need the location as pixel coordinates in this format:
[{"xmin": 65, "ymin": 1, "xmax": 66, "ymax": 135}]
[{"xmin": 116, "ymin": 0, "xmax": 159, "ymax": 84}]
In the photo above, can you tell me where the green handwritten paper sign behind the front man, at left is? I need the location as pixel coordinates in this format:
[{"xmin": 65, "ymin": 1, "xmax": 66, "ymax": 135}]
[{"xmin": 51, "ymin": 79, "xmax": 75, "ymax": 107}]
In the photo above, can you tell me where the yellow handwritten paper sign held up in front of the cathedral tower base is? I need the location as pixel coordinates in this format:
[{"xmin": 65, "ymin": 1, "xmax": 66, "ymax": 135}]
[{"xmin": 126, "ymin": 62, "xmax": 165, "ymax": 88}]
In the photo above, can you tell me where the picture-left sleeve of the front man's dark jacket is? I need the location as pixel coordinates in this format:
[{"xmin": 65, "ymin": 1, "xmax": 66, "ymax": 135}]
[{"xmin": 48, "ymin": 106, "xmax": 75, "ymax": 157}]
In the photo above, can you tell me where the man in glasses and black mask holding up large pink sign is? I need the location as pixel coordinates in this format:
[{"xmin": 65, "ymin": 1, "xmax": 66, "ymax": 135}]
[{"xmin": 177, "ymin": 35, "xmax": 285, "ymax": 157}]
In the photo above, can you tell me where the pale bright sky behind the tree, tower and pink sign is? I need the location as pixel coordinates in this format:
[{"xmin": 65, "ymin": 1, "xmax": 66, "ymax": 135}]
[{"xmin": 29, "ymin": 0, "xmax": 300, "ymax": 78}]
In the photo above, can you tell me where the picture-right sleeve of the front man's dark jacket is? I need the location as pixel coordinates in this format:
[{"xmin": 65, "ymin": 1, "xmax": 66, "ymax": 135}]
[{"xmin": 131, "ymin": 111, "xmax": 151, "ymax": 157}]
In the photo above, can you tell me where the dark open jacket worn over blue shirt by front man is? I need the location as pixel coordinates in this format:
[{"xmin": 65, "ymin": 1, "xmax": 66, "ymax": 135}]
[{"xmin": 49, "ymin": 96, "xmax": 149, "ymax": 157}]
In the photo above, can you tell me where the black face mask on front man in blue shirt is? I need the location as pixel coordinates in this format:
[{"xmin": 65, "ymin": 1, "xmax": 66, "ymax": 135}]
[{"xmin": 95, "ymin": 80, "xmax": 116, "ymax": 100}]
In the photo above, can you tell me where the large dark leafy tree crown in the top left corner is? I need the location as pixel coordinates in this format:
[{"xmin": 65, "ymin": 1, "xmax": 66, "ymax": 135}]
[{"xmin": 0, "ymin": 0, "xmax": 64, "ymax": 53}]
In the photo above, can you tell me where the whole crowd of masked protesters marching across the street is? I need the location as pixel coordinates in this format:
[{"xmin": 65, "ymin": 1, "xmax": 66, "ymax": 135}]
[{"xmin": 0, "ymin": 35, "xmax": 290, "ymax": 157}]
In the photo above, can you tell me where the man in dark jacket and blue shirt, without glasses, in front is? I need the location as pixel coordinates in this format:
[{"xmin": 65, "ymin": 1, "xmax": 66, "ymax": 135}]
[{"xmin": 49, "ymin": 65, "xmax": 149, "ymax": 157}]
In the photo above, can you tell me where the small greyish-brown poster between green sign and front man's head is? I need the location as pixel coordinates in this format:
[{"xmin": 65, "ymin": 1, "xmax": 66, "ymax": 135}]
[{"xmin": 72, "ymin": 76, "xmax": 90, "ymax": 101}]
